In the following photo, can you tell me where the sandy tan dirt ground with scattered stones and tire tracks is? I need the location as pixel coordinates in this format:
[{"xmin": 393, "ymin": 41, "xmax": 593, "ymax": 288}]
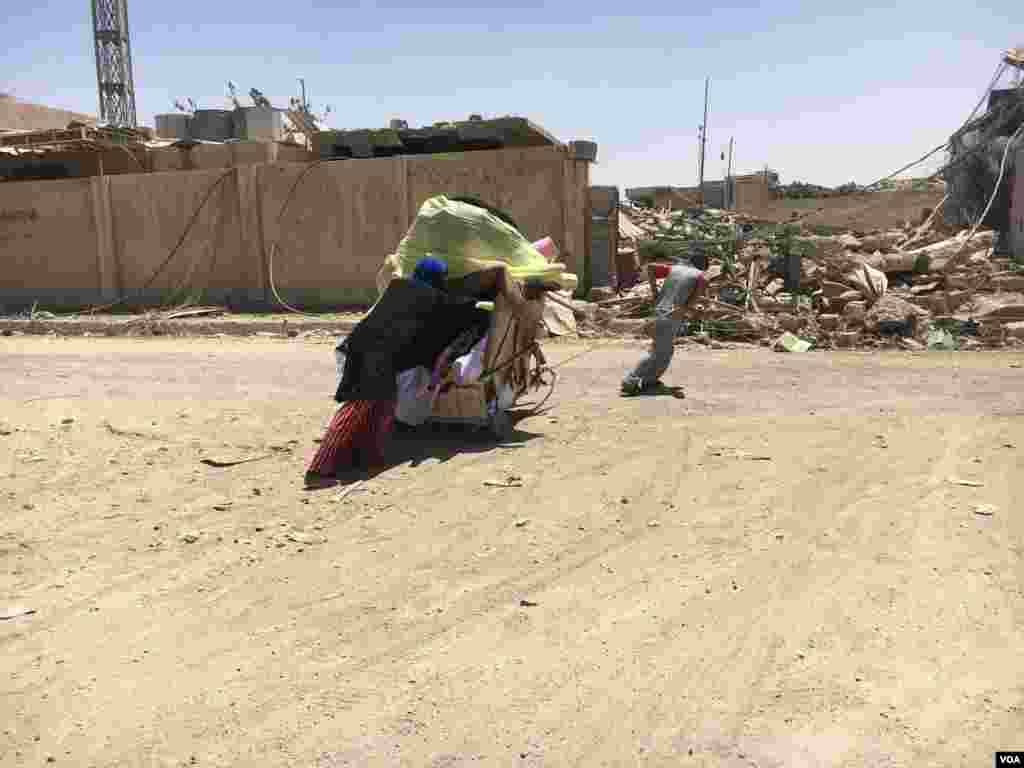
[{"xmin": 0, "ymin": 338, "xmax": 1024, "ymax": 768}]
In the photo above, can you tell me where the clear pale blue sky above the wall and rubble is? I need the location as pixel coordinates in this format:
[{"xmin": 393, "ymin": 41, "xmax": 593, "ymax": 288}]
[{"xmin": 0, "ymin": 0, "xmax": 1024, "ymax": 186}]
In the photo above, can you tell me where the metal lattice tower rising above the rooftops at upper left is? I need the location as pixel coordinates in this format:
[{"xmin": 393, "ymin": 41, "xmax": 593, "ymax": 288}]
[{"xmin": 91, "ymin": 0, "xmax": 136, "ymax": 128}]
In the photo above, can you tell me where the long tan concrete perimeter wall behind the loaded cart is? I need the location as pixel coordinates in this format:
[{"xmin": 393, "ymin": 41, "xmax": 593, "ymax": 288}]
[{"xmin": 0, "ymin": 147, "xmax": 589, "ymax": 311}]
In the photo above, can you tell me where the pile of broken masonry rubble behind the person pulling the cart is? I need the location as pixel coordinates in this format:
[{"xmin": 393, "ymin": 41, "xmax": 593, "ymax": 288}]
[{"xmin": 548, "ymin": 202, "xmax": 1024, "ymax": 351}]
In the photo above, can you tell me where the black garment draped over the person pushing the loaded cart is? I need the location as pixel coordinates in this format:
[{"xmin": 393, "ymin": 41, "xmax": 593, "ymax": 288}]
[{"xmin": 335, "ymin": 279, "xmax": 490, "ymax": 402}]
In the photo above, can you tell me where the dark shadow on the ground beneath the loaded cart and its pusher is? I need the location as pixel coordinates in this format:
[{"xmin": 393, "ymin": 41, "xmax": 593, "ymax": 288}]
[{"xmin": 305, "ymin": 409, "xmax": 544, "ymax": 490}]
